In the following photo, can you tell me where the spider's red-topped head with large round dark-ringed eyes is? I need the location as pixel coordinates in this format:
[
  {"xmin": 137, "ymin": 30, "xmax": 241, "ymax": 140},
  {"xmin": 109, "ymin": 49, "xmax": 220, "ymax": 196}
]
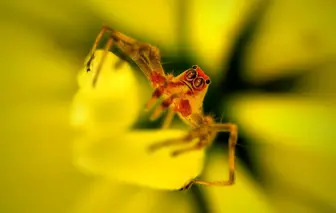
[{"xmin": 181, "ymin": 65, "xmax": 210, "ymax": 92}]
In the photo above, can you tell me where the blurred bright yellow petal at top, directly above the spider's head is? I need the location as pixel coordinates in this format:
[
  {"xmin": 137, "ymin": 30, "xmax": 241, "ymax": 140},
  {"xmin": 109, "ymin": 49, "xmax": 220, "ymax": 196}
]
[{"xmin": 186, "ymin": 0, "xmax": 256, "ymax": 71}]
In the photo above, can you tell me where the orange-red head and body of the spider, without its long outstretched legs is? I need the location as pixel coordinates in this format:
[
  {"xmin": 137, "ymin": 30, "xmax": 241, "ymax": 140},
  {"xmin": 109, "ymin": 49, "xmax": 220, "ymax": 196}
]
[{"xmin": 147, "ymin": 65, "xmax": 210, "ymax": 127}]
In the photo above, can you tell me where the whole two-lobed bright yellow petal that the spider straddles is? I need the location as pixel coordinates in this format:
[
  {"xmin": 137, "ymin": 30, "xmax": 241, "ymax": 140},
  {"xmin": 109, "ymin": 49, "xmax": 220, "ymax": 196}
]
[{"xmin": 72, "ymin": 51, "xmax": 203, "ymax": 189}]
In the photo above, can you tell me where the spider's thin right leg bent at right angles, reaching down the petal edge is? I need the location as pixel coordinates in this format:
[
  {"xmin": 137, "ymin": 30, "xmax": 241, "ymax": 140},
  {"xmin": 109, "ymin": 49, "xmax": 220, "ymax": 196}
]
[{"xmin": 182, "ymin": 123, "xmax": 238, "ymax": 190}]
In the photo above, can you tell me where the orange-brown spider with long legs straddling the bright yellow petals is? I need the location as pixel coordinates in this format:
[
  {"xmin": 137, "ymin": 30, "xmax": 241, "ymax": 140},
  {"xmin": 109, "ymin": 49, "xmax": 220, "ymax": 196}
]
[{"xmin": 86, "ymin": 26, "xmax": 238, "ymax": 190}]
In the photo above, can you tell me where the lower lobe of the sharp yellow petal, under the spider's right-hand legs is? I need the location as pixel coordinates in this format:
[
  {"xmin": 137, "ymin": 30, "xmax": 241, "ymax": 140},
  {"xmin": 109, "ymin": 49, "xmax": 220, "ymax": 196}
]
[{"xmin": 75, "ymin": 130, "xmax": 204, "ymax": 189}]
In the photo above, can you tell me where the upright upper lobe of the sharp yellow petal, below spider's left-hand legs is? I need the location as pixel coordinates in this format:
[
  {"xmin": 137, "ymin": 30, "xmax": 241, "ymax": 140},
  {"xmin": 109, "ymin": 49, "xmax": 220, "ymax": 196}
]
[{"xmin": 71, "ymin": 50, "xmax": 142, "ymax": 131}]
